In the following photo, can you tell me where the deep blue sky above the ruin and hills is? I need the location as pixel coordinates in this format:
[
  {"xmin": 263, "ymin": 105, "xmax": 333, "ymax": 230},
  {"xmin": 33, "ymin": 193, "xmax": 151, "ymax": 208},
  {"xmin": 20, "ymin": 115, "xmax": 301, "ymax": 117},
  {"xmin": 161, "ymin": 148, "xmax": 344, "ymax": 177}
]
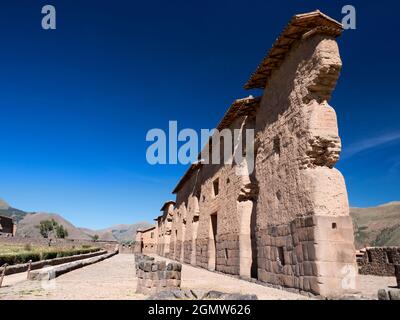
[{"xmin": 0, "ymin": 0, "xmax": 400, "ymax": 228}]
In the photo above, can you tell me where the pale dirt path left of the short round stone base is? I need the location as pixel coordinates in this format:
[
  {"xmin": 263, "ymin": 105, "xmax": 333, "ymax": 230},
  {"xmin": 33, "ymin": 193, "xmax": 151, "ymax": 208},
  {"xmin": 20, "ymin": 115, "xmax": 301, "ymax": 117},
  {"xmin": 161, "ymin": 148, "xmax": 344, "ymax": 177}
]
[{"xmin": 0, "ymin": 254, "xmax": 146, "ymax": 300}]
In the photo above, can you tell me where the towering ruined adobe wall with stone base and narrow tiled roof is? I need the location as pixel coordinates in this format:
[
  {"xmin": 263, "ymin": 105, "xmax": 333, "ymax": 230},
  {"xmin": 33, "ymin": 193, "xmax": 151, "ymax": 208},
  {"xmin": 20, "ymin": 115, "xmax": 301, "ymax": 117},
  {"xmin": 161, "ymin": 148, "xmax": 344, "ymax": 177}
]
[{"xmin": 142, "ymin": 11, "xmax": 357, "ymax": 296}]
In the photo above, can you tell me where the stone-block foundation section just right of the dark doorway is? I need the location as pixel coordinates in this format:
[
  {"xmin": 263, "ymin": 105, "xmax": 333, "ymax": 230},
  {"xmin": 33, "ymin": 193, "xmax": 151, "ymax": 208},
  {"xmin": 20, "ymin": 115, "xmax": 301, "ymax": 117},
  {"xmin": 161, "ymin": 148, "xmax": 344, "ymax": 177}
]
[{"xmin": 216, "ymin": 234, "xmax": 240, "ymax": 274}]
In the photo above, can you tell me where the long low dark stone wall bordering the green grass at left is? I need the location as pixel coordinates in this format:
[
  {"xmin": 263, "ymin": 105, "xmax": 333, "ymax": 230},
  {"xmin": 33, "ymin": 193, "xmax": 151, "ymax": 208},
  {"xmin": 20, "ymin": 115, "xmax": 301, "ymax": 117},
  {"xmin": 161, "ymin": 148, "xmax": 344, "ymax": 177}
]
[{"xmin": 5, "ymin": 250, "xmax": 107, "ymax": 275}]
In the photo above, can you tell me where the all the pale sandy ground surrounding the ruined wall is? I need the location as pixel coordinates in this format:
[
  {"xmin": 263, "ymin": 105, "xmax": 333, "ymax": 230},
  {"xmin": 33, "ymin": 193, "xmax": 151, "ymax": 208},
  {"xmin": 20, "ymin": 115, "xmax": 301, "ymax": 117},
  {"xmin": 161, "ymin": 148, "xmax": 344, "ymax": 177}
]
[{"xmin": 0, "ymin": 254, "xmax": 396, "ymax": 300}]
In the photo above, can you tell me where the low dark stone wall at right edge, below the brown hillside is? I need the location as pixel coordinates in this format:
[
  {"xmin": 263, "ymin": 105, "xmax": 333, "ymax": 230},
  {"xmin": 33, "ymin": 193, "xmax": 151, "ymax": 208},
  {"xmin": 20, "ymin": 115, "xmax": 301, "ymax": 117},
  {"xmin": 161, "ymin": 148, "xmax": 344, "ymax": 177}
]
[{"xmin": 357, "ymin": 247, "xmax": 400, "ymax": 277}]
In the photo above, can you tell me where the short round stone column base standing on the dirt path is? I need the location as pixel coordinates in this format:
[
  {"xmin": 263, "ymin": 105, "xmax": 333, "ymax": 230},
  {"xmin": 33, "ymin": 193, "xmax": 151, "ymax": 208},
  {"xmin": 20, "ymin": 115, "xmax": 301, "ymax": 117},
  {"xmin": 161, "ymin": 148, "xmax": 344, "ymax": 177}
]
[{"xmin": 135, "ymin": 254, "xmax": 182, "ymax": 295}]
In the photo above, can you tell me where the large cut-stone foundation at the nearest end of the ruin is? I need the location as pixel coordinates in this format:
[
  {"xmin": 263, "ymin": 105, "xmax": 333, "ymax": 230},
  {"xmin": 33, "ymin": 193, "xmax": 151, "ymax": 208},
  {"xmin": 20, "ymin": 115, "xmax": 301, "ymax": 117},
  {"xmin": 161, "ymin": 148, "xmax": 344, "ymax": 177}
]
[{"xmin": 257, "ymin": 216, "xmax": 356, "ymax": 294}]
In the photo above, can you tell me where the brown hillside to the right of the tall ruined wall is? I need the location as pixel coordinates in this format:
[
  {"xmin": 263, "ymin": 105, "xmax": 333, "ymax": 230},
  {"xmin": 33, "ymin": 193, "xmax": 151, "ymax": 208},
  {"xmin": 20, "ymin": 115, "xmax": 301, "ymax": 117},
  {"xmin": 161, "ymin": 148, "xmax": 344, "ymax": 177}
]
[{"xmin": 350, "ymin": 201, "xmax": 400, "ymax": 249}]
